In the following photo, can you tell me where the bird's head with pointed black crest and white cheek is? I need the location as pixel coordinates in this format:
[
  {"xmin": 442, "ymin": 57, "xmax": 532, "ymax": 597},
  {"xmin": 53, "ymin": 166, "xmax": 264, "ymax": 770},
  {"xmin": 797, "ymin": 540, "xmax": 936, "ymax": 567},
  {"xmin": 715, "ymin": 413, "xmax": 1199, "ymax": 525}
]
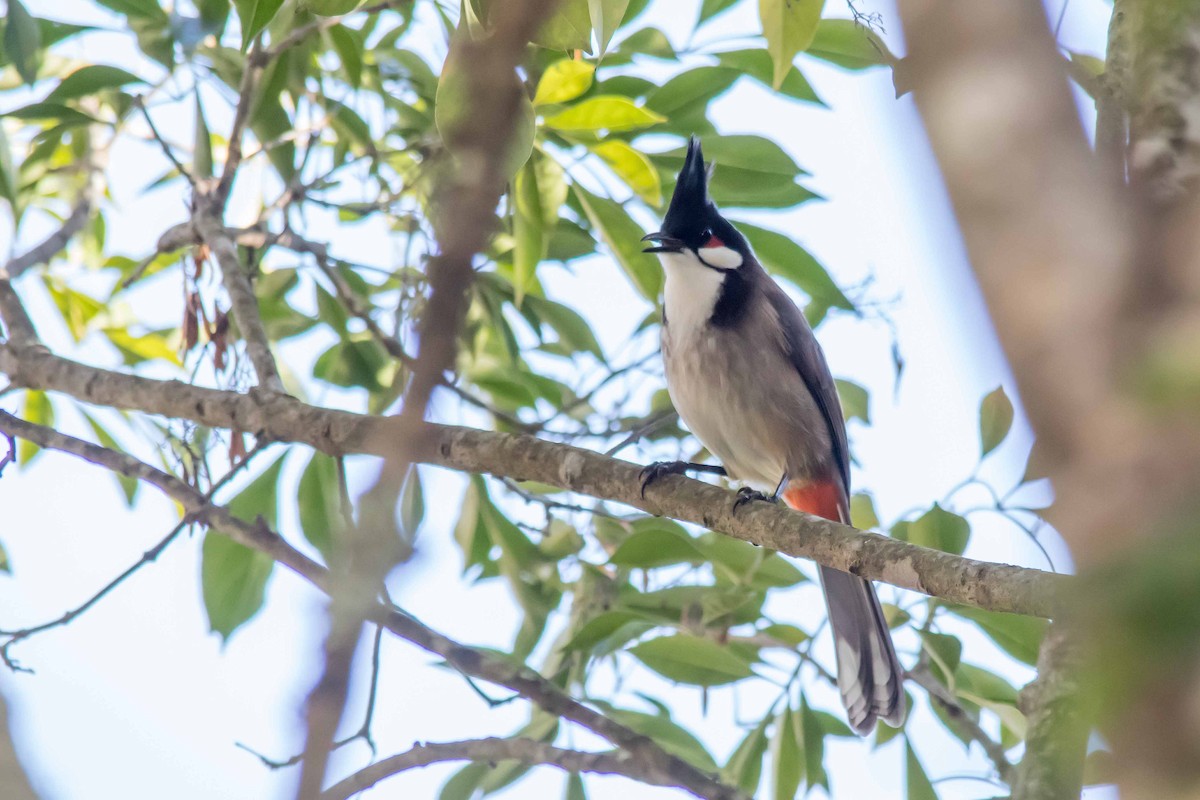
[{"xmin": 642, "ymin": 137, "xmax": 750, "ymax": 271}]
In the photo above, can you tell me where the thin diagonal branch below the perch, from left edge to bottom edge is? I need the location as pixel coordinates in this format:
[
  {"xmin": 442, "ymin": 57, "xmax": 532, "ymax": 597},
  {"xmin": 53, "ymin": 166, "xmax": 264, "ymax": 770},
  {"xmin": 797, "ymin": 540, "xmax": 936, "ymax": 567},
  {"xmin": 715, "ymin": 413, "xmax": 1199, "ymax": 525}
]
[{"xmin": 0, "ymin": 411, "xmax": 746, "ymax": 800}]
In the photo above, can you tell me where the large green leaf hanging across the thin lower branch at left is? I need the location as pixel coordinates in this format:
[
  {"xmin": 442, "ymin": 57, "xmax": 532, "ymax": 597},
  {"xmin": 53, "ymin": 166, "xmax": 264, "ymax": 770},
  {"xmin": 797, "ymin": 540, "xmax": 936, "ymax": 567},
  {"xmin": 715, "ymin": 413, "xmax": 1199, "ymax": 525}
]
[{"xmin": 200, "ymin": 457, "xmax": 283, "ymax": 642}]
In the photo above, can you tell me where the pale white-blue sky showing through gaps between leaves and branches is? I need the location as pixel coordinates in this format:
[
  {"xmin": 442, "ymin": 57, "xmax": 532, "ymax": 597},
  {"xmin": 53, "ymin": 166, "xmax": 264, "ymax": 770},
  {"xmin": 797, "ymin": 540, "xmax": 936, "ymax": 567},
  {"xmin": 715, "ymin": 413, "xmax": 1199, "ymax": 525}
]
[{"xmin": 0, "ymin": 0, "xmax": 1110, "ymax": 800}]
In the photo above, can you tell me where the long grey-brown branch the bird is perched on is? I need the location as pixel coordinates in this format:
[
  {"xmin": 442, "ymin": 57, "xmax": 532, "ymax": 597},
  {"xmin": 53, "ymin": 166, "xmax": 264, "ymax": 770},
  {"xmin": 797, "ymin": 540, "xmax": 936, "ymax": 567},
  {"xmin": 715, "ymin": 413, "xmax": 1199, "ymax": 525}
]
[{"xmin": 0, "ymin": 343, "xmax": 1074, "ymax": 616}]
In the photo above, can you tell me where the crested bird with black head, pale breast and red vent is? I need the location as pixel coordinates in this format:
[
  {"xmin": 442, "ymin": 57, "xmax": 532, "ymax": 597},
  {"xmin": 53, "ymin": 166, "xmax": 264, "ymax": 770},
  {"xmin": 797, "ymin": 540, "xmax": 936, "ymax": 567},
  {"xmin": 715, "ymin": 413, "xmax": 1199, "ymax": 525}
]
[{"xmin": 642, "ymin": 136, "xmax": 906, "ymax": 735}]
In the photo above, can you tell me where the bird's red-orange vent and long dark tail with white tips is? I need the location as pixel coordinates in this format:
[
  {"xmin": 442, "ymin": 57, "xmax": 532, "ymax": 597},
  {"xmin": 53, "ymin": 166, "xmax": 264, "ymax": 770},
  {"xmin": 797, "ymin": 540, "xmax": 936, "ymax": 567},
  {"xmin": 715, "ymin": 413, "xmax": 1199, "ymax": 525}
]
[{"xmin": 782, "ymin": 481, "xmax": 905, "ymax": 736}]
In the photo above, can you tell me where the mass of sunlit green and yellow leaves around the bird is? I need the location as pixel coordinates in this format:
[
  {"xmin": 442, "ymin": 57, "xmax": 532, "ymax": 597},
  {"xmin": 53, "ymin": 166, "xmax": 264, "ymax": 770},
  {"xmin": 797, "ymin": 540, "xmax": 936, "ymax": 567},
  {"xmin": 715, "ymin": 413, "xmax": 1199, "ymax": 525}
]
[{"xmin": 0, "ymin": 0, "xmax": 1094, "ymax": 799}]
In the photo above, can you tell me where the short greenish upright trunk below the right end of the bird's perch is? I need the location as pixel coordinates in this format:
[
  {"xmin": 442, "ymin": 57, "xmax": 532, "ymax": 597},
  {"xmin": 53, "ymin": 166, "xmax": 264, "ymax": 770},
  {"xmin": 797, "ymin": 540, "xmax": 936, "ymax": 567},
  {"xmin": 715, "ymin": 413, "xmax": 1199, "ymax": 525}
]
[{"xmin": 1013, "ymin": 622, "xmax": 1090, "ymax": 800}]
